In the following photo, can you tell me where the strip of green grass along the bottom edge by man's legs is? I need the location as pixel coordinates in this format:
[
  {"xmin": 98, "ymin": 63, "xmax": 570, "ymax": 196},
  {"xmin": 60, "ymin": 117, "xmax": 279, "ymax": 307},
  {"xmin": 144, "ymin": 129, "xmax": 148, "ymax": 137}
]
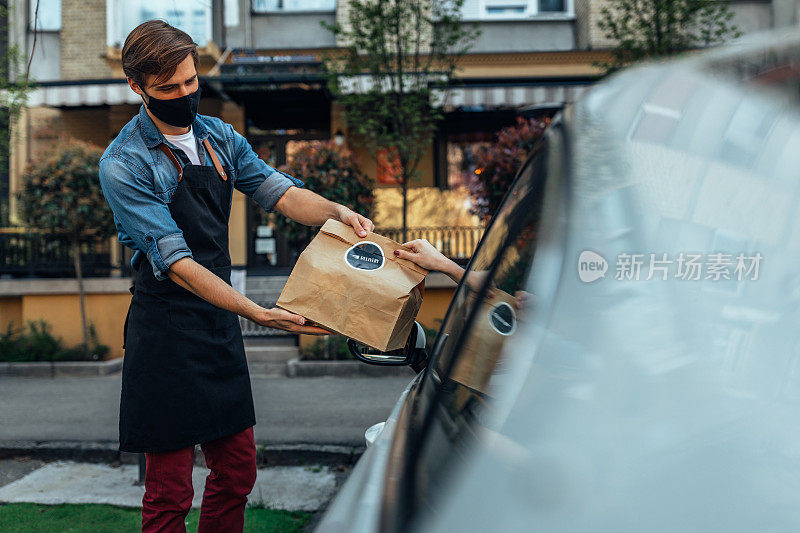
[{"xmin": 0, "ymin": 503, "xmax": 311, "ymax": 533}]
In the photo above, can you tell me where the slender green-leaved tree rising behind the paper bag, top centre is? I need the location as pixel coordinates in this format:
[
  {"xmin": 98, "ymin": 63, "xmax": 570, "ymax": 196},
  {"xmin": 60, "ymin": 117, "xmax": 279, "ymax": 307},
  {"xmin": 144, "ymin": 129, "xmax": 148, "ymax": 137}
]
[{"xmin": 322, "ymin": 0, "xmax": 478, "ymax": 239}]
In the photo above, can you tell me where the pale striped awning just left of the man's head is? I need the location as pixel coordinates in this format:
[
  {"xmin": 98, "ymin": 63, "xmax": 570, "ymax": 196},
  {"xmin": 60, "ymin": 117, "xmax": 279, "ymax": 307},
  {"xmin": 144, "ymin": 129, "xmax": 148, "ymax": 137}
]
[{"xmin": 28, "ymin": 80, "xmax": 142, "ymax": 107}]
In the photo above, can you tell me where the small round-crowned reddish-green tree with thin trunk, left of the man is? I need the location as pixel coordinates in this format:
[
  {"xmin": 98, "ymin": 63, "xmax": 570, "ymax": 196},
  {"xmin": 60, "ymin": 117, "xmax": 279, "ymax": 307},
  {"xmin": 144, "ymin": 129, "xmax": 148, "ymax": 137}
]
[{"xmin": 18, "ymin": 140, "xmax": 116, "ymax": 351}]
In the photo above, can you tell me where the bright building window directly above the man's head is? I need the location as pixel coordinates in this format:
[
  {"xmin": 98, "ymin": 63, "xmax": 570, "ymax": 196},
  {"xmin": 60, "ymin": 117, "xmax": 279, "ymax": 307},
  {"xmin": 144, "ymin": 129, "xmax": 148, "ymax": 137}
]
[{"xmin": 106, "ymin": 0, "xmax": 211, "ymax": 48}]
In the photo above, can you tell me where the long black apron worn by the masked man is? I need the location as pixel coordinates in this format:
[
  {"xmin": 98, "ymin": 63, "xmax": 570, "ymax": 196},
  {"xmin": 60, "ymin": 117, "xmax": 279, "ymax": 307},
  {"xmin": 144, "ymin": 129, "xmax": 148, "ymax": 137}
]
[{"xmin": 119, "ymin": 139, "xmax": 256, "ymax": 453}]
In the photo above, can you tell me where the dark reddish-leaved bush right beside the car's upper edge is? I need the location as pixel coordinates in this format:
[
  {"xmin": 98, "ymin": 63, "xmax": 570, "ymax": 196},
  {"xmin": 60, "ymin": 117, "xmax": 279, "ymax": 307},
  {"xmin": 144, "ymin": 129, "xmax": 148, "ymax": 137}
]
[{"xmin": 468, "ymin": 117, "xmax": 550, "ymax": 222}]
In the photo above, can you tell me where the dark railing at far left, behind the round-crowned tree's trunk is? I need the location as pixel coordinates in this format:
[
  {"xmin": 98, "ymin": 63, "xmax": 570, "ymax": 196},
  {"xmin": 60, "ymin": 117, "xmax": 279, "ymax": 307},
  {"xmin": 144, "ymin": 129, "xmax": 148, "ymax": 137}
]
[{"xmin": 0, "ymin": 231, "xmax": 111, "ymax": 277}]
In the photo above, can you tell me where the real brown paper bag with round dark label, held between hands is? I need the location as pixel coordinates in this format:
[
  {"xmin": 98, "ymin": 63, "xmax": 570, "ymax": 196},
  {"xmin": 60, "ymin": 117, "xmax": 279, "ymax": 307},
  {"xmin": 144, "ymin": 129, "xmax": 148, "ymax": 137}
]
[{"xmin": 277, "ymin": 220, "xmax": 428, "ymax": 351}]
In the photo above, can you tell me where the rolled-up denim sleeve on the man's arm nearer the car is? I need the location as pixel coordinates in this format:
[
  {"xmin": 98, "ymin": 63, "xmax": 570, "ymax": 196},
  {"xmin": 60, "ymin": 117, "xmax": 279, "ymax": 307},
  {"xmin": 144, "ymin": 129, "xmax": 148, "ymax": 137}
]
[{"xmin": 230, "ymin": 127, "xmax": 303, "ymax": 211}]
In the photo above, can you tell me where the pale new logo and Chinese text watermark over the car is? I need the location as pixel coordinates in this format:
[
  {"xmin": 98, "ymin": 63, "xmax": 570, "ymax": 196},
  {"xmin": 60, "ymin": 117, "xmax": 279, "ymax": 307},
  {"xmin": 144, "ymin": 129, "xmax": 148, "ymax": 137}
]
[{"xmin": 578, "ymin": 250, "xmax": 764, "ymax": 283}]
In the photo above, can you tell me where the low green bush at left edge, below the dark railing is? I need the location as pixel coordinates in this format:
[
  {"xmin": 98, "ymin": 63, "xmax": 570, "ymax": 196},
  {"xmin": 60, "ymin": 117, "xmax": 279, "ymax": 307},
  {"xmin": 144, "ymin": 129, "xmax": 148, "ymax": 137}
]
[{"xmin": 0, "ymin": 320, "xmax": 109, "ymax": 363}]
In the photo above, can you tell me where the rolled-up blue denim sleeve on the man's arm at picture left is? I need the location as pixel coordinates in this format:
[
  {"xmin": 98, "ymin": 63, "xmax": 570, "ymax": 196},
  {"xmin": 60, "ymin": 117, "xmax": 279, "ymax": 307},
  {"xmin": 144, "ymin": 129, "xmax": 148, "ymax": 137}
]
[{"xmin": 100, "ymin": 156, "xmax": 192, "ymax": 281}]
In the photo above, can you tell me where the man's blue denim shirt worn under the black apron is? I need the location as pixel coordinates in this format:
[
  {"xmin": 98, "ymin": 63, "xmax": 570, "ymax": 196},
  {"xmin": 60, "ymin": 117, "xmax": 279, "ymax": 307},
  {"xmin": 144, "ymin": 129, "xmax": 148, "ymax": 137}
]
[{"xmin": 100, "ymin": 105, "xmax": 303, "ymax": 281}]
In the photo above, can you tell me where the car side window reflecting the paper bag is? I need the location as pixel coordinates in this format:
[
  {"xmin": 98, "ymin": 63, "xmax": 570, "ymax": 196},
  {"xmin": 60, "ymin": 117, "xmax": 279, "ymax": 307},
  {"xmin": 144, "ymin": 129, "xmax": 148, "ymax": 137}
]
[{"xmin": 398, "ymin": 123, "xmax": 565, "ymax": 524}]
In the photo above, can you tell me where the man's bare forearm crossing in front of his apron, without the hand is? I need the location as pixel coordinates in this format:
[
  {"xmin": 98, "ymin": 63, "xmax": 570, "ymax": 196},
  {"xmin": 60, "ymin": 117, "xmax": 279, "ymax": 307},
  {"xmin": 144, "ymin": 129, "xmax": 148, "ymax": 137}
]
[{"xmin": 167, "ymin": 257, "xmax": 264, "ymax": 320}]
